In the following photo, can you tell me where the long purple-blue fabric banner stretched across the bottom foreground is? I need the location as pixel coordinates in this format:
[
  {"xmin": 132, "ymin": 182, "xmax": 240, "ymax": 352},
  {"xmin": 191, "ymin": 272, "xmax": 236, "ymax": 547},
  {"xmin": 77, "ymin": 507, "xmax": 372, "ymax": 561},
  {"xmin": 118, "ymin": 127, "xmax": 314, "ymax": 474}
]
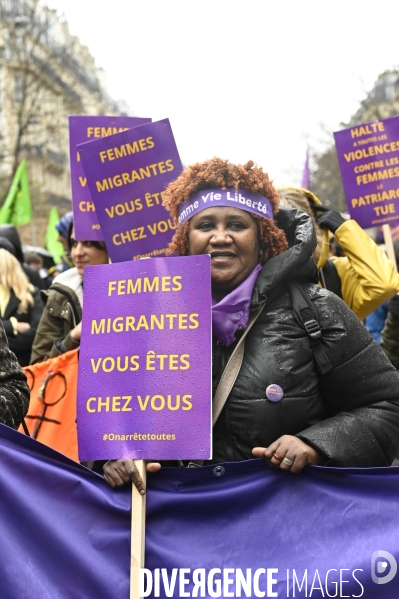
[{"xmin": 0, "ymin": 425, "xmax": 399, "ymax": 599}]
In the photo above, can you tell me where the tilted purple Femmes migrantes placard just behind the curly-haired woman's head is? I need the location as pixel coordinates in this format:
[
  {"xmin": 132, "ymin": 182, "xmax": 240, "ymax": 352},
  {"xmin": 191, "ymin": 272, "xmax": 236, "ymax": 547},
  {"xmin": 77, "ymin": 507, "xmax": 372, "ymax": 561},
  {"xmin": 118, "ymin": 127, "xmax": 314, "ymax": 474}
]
[{"xmin": 78, "ymin": 119, "xmax": 182, "ymax": 262}]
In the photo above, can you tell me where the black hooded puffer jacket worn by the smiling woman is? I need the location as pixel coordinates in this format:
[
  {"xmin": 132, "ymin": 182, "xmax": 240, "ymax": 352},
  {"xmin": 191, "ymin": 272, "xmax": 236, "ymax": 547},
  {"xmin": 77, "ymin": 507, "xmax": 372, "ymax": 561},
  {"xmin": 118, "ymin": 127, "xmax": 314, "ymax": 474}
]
[{"xmin": 212, "ymin": 209, "xmax": 399, "ymax": 466}]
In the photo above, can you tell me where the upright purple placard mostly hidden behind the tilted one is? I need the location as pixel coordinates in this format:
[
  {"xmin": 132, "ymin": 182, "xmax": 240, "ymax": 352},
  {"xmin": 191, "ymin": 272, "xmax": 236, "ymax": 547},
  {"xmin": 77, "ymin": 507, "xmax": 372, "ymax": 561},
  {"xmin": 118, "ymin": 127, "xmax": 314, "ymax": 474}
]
[{"xmin": 69, "ymin": 116, "xmax": 151, "ymax": 241}]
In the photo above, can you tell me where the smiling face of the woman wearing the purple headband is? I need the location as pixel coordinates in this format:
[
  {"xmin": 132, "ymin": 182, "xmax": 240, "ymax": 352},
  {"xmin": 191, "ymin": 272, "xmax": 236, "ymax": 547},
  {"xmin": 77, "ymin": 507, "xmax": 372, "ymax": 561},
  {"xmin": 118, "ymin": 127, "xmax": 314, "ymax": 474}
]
[{"xmin": 188, "ymin": 206, "xmax": 260, "ymax": 300}]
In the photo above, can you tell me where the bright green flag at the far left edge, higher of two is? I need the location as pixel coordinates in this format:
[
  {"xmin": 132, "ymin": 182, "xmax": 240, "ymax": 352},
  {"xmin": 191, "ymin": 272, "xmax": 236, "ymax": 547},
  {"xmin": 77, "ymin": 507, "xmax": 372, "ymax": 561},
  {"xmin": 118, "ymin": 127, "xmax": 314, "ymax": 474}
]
[{"xmin": 0, "ymin": 160, "xmax": 32, "ymax": 227}]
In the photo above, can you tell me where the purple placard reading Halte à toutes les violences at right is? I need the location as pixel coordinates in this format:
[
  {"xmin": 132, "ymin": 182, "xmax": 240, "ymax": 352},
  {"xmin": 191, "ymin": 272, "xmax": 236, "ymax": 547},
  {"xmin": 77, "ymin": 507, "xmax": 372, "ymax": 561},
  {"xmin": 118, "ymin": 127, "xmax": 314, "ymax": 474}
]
[{"xmin": 334, "ymin": 117, "xmax": 399, "ymax": 229}]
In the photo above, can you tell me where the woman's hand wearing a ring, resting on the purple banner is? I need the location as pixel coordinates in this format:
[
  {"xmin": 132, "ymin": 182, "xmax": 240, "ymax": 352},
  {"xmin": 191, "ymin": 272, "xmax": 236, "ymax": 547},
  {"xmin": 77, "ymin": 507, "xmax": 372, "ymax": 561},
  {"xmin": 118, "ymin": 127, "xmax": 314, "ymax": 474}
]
[{"xmin": 252, "ymin": 435, "xmax": 323, "ymax": 474}]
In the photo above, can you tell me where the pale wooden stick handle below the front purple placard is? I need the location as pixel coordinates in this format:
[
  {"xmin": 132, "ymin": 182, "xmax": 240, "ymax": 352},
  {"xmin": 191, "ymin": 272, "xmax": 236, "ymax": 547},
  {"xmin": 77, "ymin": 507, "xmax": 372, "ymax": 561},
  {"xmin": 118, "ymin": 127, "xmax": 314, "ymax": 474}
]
[{"xmin": 130, "ymin": 460, "xmax": 146, "ymax": 599}]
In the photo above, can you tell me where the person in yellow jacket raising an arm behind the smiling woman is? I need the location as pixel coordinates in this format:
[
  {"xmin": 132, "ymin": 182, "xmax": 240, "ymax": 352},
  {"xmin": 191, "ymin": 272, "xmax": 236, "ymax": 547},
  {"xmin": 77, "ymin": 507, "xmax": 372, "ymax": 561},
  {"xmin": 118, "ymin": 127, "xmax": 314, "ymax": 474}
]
[{"xmin": 279, "ymin": 187, "xmax": 399, "ymax": 320}]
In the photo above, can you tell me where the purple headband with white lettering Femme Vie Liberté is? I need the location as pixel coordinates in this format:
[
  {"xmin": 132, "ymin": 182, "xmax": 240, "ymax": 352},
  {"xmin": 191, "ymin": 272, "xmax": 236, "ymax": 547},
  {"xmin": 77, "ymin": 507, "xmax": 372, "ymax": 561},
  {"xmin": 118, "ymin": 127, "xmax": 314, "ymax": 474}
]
[{"xmin": 179, "ymin": 187, "xmax": 273, "ymax": 225}]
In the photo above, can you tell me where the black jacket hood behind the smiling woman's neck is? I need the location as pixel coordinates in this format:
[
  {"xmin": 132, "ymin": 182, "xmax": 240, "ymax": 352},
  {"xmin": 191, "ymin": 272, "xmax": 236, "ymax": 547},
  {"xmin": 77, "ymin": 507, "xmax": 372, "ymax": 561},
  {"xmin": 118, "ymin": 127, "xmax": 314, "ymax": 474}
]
[{"xmin": 252, "ymin": 208, "xmax": 317, "ymax": 307}]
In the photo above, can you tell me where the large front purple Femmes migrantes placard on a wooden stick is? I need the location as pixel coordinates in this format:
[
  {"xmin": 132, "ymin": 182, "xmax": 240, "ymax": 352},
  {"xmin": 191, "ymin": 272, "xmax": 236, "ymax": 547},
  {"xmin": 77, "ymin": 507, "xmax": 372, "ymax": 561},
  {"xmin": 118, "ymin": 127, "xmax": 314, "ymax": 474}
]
[{"xmin": 77, "ymin": 256, "xmax": 211, "ymax": 460}]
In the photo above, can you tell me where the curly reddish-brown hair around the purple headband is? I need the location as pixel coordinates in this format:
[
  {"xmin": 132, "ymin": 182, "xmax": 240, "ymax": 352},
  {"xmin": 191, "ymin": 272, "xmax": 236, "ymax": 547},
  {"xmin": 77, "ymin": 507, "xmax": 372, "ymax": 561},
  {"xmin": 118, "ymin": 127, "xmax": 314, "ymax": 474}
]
[{"xmin": 163, "ymin": 158, "xmax": 288, "ymax": 263}]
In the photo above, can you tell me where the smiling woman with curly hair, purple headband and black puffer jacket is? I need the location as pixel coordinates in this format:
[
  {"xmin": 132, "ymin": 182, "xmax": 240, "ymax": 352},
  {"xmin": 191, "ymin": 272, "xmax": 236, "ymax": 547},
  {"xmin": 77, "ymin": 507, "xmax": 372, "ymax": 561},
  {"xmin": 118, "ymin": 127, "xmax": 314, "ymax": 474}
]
[{"xmin": 104, "ymin": 158, "xmax": 399, "ymax": 493}]
